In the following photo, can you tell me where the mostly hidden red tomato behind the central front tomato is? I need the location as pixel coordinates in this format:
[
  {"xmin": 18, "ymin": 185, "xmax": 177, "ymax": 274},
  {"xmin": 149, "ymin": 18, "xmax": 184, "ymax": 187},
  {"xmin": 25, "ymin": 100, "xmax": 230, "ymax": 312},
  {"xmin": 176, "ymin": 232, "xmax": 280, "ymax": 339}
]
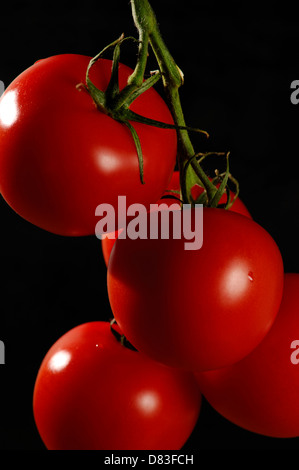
[{"xmin": 101, "ymin": 171, "xmax": 252, "ymax": 266}]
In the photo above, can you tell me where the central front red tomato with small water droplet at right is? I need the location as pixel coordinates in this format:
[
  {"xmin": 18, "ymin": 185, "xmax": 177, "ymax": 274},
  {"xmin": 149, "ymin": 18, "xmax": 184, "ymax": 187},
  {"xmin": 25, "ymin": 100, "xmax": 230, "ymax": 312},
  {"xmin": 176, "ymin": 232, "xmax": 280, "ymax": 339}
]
[{"xmin": 107, "ymin": 208, "xmax": 283, "ymax": 371}]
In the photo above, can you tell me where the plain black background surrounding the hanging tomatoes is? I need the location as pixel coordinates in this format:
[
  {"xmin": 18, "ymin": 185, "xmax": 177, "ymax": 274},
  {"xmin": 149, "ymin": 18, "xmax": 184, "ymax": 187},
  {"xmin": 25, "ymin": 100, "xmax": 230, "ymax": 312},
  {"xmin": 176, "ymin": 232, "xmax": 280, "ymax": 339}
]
[{"xmin": 0, "ymin": 0, "xmax": 299, "ymax": 451}]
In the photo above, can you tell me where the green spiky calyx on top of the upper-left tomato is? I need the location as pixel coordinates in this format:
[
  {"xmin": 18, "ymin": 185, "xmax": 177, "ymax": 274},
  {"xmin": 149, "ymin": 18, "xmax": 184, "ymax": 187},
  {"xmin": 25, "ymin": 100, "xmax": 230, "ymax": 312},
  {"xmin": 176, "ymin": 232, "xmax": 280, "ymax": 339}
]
[{"xmin": 78, "ymin": 34, "xmax": 208, "ymax": 184}]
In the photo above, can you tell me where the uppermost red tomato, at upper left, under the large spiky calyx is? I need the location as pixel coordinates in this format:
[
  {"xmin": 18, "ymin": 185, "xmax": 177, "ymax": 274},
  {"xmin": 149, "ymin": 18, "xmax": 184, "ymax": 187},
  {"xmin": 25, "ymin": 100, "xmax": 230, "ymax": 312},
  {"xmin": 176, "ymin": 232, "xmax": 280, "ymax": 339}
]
[{"xmin": 0, "ymin": 54, "xmax": 177, "ymax": 236}]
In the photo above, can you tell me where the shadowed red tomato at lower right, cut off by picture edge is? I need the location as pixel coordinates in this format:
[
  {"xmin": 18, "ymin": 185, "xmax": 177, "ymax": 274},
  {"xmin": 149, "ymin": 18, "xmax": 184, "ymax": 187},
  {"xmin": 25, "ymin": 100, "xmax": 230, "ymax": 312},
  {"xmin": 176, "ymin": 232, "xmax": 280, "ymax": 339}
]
[{"xmin": 196, "ymin": 273, "xmax": 299, "ymax": 438}]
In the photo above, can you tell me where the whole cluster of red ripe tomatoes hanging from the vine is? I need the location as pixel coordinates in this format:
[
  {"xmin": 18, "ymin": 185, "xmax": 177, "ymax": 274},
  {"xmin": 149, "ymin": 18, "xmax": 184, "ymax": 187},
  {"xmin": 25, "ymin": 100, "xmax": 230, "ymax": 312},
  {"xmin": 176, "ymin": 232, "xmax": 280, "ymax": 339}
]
[{"xmin": 0, "ymin": 23, "xmax": 299, "ymax": 450}]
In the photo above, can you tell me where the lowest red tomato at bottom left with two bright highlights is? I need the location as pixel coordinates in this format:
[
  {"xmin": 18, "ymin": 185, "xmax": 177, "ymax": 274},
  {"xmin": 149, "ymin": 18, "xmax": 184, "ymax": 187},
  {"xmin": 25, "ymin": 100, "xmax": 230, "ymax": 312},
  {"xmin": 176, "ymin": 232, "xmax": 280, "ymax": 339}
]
[{"xmin": 33, "ymin": 322, "xmax": 201, "ymax": 450}]
